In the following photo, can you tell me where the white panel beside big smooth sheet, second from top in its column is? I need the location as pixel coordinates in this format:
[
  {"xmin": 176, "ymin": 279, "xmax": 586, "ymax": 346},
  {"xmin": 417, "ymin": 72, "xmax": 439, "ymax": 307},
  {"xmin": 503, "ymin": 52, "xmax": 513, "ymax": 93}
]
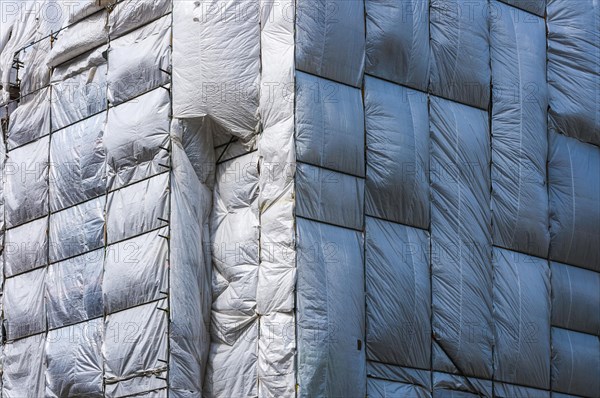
[{"xmin": 107, "ymin": 16, "xmax": 171, "ymax": 104}]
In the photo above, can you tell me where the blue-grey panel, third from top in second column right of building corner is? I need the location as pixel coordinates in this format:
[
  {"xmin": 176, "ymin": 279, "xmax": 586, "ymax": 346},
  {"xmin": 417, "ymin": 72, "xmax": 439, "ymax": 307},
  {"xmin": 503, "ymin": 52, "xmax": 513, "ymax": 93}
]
[{"xmin": 365, "ymin": 217, "xmax": 431, "ymax": 369}]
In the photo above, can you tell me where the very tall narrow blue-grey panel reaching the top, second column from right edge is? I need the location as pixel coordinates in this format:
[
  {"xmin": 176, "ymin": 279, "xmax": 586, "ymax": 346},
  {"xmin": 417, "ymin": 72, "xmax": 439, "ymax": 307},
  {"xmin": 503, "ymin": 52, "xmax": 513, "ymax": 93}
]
[{"xmin": 491, "ymin": 3, "xmax": 550, "ymax": 257}]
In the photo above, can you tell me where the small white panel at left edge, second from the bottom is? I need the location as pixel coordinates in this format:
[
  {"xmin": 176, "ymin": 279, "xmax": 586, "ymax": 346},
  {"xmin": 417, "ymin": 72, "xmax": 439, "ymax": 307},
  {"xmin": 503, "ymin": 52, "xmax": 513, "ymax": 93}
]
[{"xmin": 3, "ymin": 268, "xmax": 46, "ymax": 338}]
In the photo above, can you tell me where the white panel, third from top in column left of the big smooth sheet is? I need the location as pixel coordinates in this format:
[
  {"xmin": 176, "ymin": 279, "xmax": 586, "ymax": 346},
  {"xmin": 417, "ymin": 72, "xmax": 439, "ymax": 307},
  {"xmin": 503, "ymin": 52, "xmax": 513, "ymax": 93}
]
[{"xmin": 104, "ymin": 88, "xmax": 170, "ymax": 189}]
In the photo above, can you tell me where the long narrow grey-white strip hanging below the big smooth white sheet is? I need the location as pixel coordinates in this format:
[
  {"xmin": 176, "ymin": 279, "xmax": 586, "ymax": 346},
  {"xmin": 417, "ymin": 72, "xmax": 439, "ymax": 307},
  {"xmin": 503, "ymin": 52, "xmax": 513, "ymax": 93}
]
[{"xmin": 169, "ymin": 120, "xmax": 215, "ymax": 396}]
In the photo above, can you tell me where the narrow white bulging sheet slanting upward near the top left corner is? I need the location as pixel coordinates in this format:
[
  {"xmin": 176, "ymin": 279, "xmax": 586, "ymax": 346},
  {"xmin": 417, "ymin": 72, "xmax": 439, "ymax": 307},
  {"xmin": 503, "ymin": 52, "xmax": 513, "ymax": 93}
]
[{"xmin": 46, "ymin": 12, "xmax": 108, "ymax": 68}]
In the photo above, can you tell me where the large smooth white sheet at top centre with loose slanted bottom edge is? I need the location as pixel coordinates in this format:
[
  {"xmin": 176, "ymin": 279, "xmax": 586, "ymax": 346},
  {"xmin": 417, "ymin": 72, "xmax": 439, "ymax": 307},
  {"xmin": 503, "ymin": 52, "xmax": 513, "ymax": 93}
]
[{"xmin": 173, "ymin": 0, "xmax": 260, "ymax": 146}]
